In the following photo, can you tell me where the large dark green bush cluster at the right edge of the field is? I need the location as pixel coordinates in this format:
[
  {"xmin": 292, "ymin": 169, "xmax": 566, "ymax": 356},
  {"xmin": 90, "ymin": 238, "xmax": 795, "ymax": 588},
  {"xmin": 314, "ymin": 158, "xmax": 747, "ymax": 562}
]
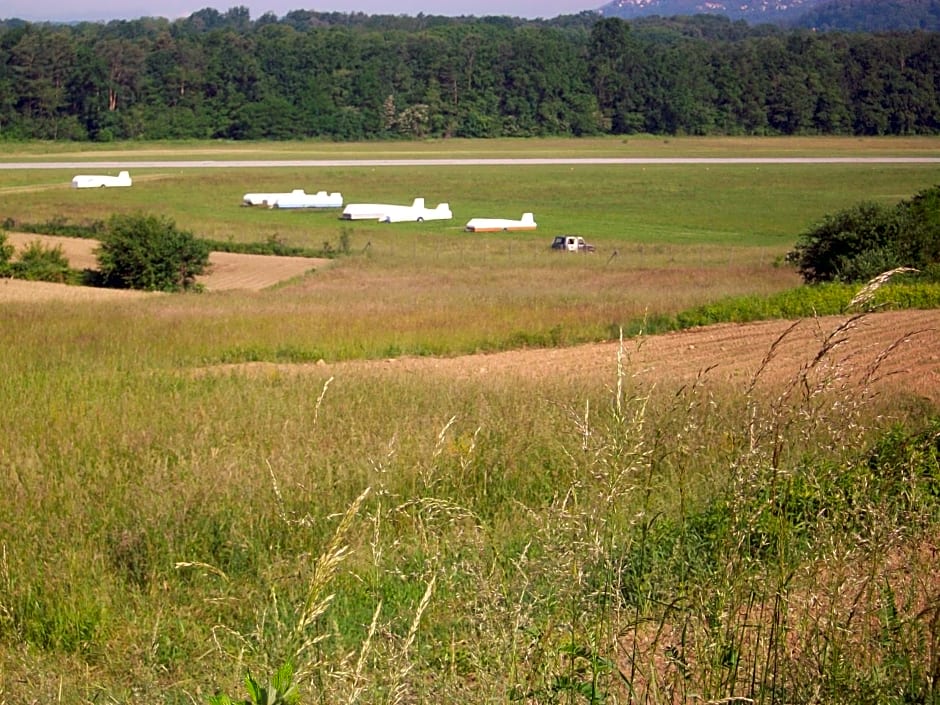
[{"xmin": 789, "ymin": 186, "xmax": 940, "ymax": 283}]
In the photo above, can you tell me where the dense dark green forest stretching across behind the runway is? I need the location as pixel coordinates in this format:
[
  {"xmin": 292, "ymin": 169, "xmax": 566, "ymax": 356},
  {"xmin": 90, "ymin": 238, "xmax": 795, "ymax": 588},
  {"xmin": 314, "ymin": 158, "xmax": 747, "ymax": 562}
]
[{"xmin": 0, "ymin": 7, "xmax": 940, "ymax": 141}]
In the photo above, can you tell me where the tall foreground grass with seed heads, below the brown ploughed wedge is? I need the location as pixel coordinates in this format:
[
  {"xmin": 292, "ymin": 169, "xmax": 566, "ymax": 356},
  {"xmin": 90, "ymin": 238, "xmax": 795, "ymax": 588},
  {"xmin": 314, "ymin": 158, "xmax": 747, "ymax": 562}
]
[{"xmin": 0, "ymin": 296, "xmax": 938, "ymax": 703}]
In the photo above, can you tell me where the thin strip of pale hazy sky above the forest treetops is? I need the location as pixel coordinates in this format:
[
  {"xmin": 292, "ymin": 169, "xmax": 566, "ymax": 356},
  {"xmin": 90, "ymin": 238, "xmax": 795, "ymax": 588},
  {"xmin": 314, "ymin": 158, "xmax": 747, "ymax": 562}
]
[{"xmin": 0, "ymin": 0, "xmax": 607, "ymax": 22}]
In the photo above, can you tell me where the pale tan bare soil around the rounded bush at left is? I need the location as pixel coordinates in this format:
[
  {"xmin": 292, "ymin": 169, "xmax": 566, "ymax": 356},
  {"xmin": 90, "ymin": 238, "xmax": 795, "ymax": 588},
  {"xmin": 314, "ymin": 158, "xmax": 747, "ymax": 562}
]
[{"xmin": 0, "ymin": 233, "xmax": 330, "ymax": 301}]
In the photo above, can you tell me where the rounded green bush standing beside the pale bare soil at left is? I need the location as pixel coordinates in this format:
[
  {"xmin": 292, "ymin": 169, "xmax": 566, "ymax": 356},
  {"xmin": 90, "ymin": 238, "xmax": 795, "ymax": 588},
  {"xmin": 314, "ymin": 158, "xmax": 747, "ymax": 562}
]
[{"xmin": 96, "ymin": 215, "xmax": 209, "ymax": 291}]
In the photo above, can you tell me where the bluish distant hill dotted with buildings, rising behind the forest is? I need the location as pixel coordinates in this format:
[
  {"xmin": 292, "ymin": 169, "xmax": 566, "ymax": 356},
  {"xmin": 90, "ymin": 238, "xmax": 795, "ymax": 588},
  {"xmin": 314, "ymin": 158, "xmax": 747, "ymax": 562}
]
[{"xmin": 599, "ymin": 0, "xmax": 940, "ymax": 32}]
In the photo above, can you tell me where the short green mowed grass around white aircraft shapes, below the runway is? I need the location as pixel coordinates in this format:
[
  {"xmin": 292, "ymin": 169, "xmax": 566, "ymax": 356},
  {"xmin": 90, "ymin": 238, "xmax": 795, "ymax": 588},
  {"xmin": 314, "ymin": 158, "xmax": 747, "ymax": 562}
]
[{"xmin": 0, "ymin": 164, "xmax": 940, "ymax": 250}]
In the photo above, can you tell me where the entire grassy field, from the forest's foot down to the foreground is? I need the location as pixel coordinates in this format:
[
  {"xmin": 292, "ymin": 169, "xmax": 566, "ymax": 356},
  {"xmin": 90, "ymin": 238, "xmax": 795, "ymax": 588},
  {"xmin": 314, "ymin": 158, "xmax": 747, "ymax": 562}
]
[{"xmin": 0, "ymin": 138, "xmax": 940, "ymax": 705}]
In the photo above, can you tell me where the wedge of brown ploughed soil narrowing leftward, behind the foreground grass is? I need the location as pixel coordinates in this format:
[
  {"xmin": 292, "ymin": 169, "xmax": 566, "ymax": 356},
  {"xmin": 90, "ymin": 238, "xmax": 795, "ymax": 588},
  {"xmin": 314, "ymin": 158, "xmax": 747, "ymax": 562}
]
[{"xmin": 215, "ymin": 310, "xmax": 940, "ymax": 403}]
